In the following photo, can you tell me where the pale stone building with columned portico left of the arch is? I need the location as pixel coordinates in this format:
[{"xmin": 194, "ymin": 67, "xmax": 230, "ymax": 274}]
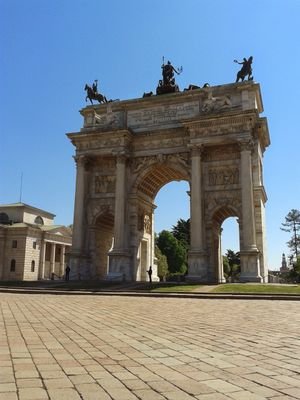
[{"xmin": 0, "ymin": 203, "xmax": 72, "ymax": 281}]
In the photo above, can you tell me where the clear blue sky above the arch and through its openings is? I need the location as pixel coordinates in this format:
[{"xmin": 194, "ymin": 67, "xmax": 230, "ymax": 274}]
[{"xmin": 0, "ymin": 0, "xmax": 300, "ymax": 268}]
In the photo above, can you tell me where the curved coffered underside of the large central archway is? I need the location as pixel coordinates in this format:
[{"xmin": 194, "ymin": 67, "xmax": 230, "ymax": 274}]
[{"xmin": 133, "ymin": 161, "xmax": 190, "ymax": 199}]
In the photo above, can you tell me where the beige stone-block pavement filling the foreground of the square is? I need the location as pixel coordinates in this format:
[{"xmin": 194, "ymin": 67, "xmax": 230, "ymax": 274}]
[{"xmin": 0, "ymin": 294, "xmax": 300, "ymax": 400}]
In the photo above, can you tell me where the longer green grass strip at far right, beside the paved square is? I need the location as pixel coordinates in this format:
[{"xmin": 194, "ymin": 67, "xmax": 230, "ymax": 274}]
[{"xmin": 211, "ymin": 283, "xmax": 300, "ymax": 294}]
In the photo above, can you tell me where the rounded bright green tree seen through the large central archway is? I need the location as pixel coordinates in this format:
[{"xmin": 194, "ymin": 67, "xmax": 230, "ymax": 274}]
[{"xmin": 156, "ymin": 230, "xmax": 187, "ymax": 274}]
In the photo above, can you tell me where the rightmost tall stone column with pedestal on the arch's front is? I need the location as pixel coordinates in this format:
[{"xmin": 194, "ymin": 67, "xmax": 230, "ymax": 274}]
[{"xmin": 240, "ymin": 141, "xmax": 262, "ymax": 282}]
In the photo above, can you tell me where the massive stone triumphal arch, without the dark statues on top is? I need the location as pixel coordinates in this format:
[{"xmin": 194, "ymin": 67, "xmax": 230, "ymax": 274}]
[{"xmin": 68, "ymin": 81, "xmax": 270, "ymax": 282}]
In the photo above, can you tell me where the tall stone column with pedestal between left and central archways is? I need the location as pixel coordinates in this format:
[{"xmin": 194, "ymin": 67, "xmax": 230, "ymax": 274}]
[{"xmin": 106, "ymin": 152, "xmax": 133, "ymax": 281}]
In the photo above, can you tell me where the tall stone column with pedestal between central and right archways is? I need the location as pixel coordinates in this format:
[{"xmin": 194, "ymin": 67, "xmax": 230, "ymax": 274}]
[{"xmin": 187, "ymin": 145, "xmax": 208, "ymax": 282}]
